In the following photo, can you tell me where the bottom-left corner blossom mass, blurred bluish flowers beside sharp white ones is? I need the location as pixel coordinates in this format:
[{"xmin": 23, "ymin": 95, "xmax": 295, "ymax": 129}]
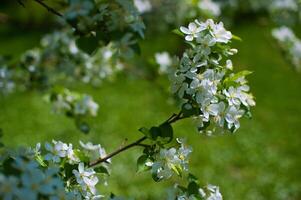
[{"xmin": 0, "ymin": 140, "xmax": 108, "ymax": 200}]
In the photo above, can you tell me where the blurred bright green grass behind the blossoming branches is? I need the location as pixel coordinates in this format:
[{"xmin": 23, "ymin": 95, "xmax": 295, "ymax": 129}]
[{"xmin": 0, "ymin": 21, "xmax": 301, "ymax": 200}]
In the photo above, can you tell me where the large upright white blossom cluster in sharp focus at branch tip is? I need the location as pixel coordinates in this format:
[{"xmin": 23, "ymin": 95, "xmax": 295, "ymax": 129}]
[{"xmin": 172, "ymin": 19, "xmax": 255, "ymax": 133}]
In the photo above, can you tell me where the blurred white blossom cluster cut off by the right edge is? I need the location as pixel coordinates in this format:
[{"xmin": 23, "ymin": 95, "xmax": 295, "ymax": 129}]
[{"xmin": 272, "ymin": 26, "xmax": 301, "ymax": 71}]
